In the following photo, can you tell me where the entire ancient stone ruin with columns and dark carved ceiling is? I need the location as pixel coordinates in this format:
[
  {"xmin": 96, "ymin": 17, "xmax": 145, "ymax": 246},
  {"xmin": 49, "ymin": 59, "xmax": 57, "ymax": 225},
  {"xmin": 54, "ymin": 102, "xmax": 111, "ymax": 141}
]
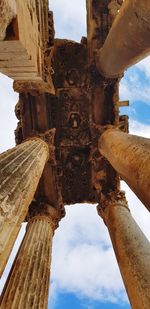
[{"xmin": 0, "ymin": 0, "xmax": 150, "ymax": 309}]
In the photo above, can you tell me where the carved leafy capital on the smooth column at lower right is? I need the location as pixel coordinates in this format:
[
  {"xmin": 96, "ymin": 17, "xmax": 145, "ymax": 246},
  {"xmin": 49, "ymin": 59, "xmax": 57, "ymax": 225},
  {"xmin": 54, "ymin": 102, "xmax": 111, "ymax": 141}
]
[{"xmin": 97, "ymin": 190, "xmax": 130, "ymax": 224}]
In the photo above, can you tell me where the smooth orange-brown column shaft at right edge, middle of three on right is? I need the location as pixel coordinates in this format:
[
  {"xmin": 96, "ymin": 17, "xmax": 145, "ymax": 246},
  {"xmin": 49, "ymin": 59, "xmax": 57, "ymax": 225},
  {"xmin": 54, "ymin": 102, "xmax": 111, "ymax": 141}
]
[{"xmin": 99, "ymin": 129, "xmax": 150, "ymax": 210}]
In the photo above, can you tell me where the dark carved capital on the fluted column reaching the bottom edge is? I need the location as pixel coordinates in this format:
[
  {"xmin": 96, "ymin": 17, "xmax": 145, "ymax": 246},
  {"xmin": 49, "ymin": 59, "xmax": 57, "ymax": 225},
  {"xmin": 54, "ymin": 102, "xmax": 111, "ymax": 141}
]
[{"xmin": 27, "ymin": 202, "xmax": 61, "ymax": 233}]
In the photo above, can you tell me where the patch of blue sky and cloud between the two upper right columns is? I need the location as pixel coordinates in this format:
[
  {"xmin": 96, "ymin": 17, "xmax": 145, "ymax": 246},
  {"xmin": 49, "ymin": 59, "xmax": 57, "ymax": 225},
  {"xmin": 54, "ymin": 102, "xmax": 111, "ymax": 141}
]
[{"xmin": 120, "ymin": 67, "xmax": 150, "ymax": 125}]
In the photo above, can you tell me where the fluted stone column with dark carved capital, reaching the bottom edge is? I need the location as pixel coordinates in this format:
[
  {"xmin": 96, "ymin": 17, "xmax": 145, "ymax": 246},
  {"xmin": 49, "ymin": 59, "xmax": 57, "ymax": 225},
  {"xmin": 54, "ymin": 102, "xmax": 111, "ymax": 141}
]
[{"xmin": 0, "ymin": 204, "xmax": 58, "ymax": 309}]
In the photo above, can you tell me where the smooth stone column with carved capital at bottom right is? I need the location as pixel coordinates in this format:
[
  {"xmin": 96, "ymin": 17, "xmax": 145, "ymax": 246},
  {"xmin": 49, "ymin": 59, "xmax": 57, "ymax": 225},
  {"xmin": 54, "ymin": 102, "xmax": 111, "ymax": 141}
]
[{"xmin": 98, "ymin": 192, "xmax": 150, "ymax": 309}]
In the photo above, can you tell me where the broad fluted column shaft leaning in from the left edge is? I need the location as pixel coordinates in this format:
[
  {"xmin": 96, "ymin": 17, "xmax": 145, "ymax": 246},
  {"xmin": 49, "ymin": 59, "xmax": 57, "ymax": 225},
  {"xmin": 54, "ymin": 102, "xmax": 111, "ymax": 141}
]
[{"xmin": 0, "ymin": 138, "xmax": 49, "ymax": 275}]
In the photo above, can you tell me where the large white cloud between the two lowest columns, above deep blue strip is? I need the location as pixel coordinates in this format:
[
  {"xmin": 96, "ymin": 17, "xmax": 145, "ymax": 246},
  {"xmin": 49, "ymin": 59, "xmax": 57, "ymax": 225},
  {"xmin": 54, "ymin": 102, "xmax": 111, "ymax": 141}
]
[{"xmin": 52, "ymin": 205, "xmax": 125, "ymax": 302}]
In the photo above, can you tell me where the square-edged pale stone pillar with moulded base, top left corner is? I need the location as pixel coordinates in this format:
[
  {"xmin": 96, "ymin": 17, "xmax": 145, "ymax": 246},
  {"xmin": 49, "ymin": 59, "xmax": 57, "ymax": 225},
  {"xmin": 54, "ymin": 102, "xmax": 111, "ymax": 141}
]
[{"xmin": 0, "ymin": 0, "xmax": 55, "ymax": 94}]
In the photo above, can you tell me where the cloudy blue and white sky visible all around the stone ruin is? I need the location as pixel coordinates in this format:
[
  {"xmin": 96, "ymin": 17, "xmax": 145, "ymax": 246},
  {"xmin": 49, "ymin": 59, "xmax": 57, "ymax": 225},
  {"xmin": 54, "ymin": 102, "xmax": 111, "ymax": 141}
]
[{"xmin": 0, "ymin": 0, "xmax": 150, "ymax": 309}]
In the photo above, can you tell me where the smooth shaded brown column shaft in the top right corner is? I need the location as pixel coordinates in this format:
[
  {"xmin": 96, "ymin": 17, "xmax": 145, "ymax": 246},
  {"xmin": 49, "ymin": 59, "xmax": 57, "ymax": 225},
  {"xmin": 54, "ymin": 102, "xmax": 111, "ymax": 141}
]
[{"xmin": 97, "ymin": 0, "xmax": 150, "ymax": 78}]
